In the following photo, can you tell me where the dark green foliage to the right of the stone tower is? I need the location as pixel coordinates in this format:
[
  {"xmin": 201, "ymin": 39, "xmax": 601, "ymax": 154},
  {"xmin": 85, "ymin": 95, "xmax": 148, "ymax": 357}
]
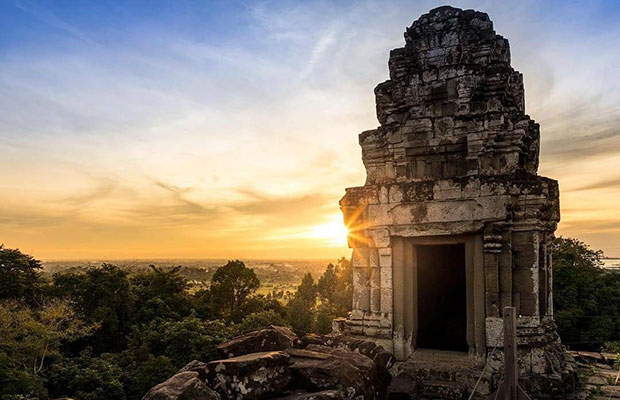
[{"xmin": 552, "ymin": 237, "xmax": 620, "ymax": 350}]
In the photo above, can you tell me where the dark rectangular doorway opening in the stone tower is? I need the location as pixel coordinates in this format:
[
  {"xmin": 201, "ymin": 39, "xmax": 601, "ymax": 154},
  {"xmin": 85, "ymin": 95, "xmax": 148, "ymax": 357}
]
[{"xmin": 416, "ymin": 244, "xmax": 469, "ymax": 351}]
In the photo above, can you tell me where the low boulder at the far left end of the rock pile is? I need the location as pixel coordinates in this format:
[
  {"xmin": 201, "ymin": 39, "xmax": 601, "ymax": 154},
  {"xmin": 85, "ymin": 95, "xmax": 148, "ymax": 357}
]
[{"xmin": 142, "ymin": 371, "xmax": 220, "ymax": 400}]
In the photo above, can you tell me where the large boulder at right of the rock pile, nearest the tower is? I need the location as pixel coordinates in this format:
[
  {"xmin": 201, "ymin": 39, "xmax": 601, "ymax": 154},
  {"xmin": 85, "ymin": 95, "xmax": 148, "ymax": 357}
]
[{"xmin": 288, "ymin": 349, "xmax": 375, "ymax": 400}]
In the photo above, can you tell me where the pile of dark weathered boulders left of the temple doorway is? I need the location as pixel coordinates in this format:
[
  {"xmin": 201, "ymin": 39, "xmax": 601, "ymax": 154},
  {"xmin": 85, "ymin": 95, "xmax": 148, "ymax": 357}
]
[{"xmin": 143, "ymin": 326, "xmax": 394, "ymax": 400}]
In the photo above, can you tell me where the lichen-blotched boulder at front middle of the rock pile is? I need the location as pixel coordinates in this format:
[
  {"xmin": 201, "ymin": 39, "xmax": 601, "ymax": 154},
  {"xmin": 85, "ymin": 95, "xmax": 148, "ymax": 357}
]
[{"xmin": 206, "ymin": 351, "xmax": 291, "ymax": 400}]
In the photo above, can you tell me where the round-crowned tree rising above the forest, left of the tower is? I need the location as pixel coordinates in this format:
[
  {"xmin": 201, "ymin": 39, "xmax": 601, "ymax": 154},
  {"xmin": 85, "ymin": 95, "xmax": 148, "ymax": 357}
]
[{"xmin": 210, "ymin": 260, "xmax": 260, "ymax": 322}]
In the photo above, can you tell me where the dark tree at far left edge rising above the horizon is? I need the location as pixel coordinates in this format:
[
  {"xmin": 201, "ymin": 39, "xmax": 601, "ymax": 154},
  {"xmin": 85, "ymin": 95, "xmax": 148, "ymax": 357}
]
[{"xmin": 0, "ymin": 244, "xmax": 43, "ymax": 303}]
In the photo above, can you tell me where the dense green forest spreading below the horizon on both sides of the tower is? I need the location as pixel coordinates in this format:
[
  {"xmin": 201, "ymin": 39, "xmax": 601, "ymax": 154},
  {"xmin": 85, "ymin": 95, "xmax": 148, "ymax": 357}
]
[{"xmin": 0, "ymin": 238, "xmax": 620, "ymax": 400}]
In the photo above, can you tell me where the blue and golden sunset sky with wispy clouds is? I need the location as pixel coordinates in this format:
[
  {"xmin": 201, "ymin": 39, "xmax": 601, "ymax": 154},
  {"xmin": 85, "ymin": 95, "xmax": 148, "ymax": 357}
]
[{"xmin": 0, "ymin": 0, "xmax": 620, "ymax": 260}]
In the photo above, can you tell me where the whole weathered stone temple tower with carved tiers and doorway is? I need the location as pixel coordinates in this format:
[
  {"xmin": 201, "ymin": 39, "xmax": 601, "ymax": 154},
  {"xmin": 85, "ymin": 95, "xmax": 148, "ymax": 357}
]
[{"xmin": 340, "ymin": 6, "xmax": 576, "ymax": 396}]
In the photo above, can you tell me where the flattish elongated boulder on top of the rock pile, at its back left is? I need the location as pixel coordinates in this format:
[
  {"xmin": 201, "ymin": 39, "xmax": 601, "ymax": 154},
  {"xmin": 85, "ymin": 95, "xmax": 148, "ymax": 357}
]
[{"xmin": 217, "ymin": 325, "xmax": 299, "ymax": 358}]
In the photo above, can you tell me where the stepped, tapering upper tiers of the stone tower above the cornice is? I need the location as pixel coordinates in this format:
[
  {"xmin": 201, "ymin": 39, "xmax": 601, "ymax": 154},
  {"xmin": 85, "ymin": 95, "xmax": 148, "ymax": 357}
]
[{"xmin": 360, "ymin": 6, "xmax": 539, "ymax": 184}]
